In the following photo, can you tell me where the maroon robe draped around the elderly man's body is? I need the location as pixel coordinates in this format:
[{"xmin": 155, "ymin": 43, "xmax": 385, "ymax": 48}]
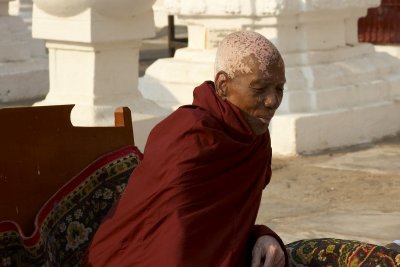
[{"xmin": 87, "ymin": 82, "xmax": 284, "ymax": 267}]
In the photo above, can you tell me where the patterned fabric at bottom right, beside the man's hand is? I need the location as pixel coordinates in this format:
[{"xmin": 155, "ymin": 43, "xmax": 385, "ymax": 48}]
[{"xmin": 286, "ymin": 238, "xmax": 400, "ymax": 267}]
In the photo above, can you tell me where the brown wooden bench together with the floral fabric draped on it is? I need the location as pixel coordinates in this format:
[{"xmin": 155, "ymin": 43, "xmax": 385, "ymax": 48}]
[{"xmin": 0, "ymin": 105, "xmax": 141, "ymax": 266}]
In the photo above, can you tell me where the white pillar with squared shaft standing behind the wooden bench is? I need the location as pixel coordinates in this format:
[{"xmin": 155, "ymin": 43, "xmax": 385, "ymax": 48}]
[{"xmin": 32, "ymin": 0, "xmax": 167, "ymax": 151}]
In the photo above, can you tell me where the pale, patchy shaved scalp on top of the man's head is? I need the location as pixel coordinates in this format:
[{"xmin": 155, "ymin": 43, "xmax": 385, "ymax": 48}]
[{"xmin": 215, "ymin": 31, "xmax": 283, "ymax": 78}]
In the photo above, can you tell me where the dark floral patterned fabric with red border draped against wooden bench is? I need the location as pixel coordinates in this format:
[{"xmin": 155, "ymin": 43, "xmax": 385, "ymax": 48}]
[{"xmin": 0, "ymin": 146, "xmax": 141, "ymax": 267}]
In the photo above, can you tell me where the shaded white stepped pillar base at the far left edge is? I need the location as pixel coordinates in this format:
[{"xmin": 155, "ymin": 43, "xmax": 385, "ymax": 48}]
[{"xmin": 0, "ymin": 0, "xmax": 48, "ymax": 104}]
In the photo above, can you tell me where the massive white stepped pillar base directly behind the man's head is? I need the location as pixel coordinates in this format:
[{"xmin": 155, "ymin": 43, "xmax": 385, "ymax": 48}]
[{"xmin": 140, "ymin": 0, "xmax": 400, "ymax": 155}]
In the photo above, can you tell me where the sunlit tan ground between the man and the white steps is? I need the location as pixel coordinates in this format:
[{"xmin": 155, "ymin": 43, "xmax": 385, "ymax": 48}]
[{"xmin": 257, "ymin": 135, "xmax": 400, "ymax": 248}]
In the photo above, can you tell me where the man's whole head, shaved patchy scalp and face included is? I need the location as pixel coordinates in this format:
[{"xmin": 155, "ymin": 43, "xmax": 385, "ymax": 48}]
[{"xmin": 214, "ymin": 31, "xmax": 286, "ymax": 135}]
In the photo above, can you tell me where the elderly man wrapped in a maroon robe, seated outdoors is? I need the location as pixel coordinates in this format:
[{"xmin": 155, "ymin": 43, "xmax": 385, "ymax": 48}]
[{"xmin": 86, "ymin": 32, "xmax": 286, "ymax": 267}]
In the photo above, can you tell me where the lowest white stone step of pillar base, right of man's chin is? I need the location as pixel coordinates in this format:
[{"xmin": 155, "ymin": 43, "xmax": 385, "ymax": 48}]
[{"xmin": 270, "ymin": 99, "xmax": 400, "ymax": 156}]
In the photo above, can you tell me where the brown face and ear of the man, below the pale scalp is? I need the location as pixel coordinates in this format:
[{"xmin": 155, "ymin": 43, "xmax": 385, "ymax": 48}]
[{"xmin": 216, "ymin": 54, "xmax": 286, "ymax": 135}]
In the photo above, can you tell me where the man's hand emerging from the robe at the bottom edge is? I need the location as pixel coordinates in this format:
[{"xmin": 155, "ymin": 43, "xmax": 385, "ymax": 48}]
[{"xmin": 251, "ymin": 235, "xmax": 285, "ymax": 267}]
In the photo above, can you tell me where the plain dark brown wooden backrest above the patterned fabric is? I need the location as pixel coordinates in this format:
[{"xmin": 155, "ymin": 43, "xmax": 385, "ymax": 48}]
[{"xmin": 0, "ymin": 105, "xmax": 134, "ymax": 235}]
